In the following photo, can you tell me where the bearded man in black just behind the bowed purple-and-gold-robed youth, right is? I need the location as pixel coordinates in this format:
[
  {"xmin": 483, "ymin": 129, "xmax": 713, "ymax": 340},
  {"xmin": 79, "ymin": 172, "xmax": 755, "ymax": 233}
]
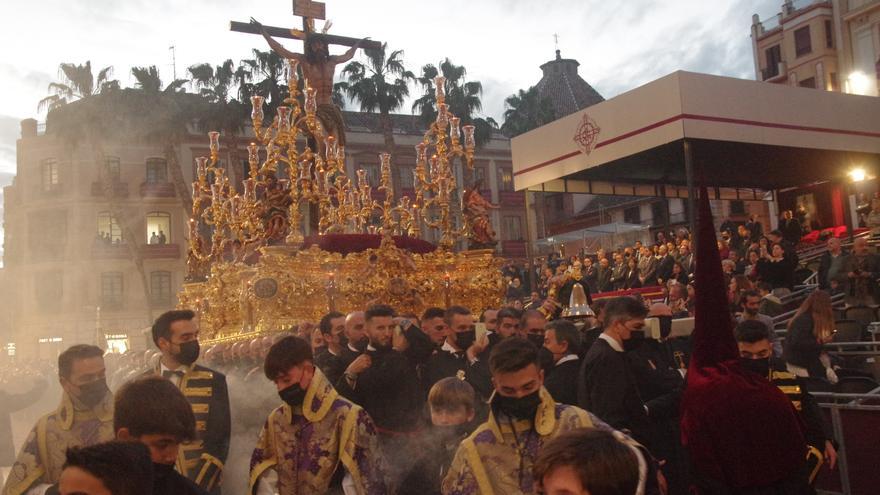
[{"xmin": 337, "ymin": 304, "xmax": 425, "ymax": 493}]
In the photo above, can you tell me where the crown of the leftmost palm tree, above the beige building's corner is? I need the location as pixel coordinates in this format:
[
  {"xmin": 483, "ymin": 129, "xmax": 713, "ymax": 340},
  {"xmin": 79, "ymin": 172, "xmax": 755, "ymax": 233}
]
[{"xmin": 37, "ymin": 60, "xmax": 119, "ymax": 111}]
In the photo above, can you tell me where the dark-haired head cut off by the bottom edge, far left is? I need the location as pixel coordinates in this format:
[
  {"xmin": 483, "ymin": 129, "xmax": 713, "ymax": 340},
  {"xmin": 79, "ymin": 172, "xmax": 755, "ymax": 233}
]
[{"xmin": 60, "ymin": 442, "xmax": 153, "ymax": 495}]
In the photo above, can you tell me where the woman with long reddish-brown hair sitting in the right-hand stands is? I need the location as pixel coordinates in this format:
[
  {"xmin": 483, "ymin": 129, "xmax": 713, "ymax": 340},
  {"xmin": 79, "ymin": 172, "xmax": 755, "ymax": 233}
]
[{"xmin": 782, "ymin": 290, "xmax": 837, "ymax": 383}]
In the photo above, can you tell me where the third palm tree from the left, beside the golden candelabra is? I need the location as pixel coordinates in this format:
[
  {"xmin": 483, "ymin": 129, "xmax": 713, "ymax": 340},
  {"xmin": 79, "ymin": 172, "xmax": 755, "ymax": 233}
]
[{"xmin": 189, "ymin": 59, "xmax": 250, "ymax": 187}]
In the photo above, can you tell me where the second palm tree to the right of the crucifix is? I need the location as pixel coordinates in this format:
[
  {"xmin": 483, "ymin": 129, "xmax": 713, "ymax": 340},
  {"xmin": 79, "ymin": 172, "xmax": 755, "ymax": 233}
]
[{"xmin": 412, "ymin": 58, "xmax": 498, "ymax": 146}]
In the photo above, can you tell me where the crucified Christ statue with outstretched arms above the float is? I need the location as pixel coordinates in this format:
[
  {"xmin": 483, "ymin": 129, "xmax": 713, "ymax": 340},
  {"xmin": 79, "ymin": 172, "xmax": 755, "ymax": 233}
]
[{"xmin": 251, "ymin": 17, "xmax": 369, "ymax": 146}]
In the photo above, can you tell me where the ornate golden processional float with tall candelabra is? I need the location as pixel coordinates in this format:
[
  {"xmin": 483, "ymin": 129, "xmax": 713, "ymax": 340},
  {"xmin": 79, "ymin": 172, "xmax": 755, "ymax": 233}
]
[{"xmin": 179, "ymin": 64, "xmax": 504, "ymax": 342}]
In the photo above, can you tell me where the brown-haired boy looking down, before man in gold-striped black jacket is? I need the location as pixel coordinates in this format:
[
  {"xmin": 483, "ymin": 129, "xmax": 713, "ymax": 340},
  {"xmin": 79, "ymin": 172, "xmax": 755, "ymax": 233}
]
[{"xmin": 113, "ymin": 376, "xmax": 208, "ymax": 495}]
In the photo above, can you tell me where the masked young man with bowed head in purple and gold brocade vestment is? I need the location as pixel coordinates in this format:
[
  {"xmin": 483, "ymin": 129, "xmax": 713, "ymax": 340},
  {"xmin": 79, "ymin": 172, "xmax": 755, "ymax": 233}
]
[{"xmin": 248, "ymin": 337, "xmax": 388, "ymax": 495}]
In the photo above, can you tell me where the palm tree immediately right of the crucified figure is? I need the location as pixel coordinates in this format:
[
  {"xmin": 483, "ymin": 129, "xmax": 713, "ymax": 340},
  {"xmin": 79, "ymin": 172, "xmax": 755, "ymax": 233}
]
[{"xmin": 333, "ymin": 43, "xmax": 415, "ymax": 153}]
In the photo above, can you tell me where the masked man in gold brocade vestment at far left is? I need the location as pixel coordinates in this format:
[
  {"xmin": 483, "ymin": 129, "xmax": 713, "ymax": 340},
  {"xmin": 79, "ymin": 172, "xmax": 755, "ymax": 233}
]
[{"xmin": 2, "ymin": 345, "xmax": 113, "ymax": 495}]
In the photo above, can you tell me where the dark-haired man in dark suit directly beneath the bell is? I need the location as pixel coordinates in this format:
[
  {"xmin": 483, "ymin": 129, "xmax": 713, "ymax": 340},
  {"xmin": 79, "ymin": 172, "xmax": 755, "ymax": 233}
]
[{"xmin": 544, "ymin": 320, "xmax": 581, "ymax": 406}]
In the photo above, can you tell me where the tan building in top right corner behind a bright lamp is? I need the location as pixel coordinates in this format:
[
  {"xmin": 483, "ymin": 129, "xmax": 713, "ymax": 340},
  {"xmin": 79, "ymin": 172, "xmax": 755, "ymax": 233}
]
[{"xmin": 751, "ymin": 0, "xmax": 880, "ymax": 96}]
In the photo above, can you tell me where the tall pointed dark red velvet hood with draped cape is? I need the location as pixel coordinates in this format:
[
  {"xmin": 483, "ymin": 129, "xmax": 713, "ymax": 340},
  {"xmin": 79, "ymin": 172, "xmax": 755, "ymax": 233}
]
[{"xmin": 681, "ymin": 186, "xmax": 806, "ymax": 493}]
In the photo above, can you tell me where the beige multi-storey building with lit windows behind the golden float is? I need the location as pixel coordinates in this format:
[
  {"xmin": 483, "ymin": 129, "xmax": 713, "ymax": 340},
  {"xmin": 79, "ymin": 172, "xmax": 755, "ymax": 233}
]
[{"xmin": 0, "ymin": 108, "xmax": 526, "ymax": 359}]
